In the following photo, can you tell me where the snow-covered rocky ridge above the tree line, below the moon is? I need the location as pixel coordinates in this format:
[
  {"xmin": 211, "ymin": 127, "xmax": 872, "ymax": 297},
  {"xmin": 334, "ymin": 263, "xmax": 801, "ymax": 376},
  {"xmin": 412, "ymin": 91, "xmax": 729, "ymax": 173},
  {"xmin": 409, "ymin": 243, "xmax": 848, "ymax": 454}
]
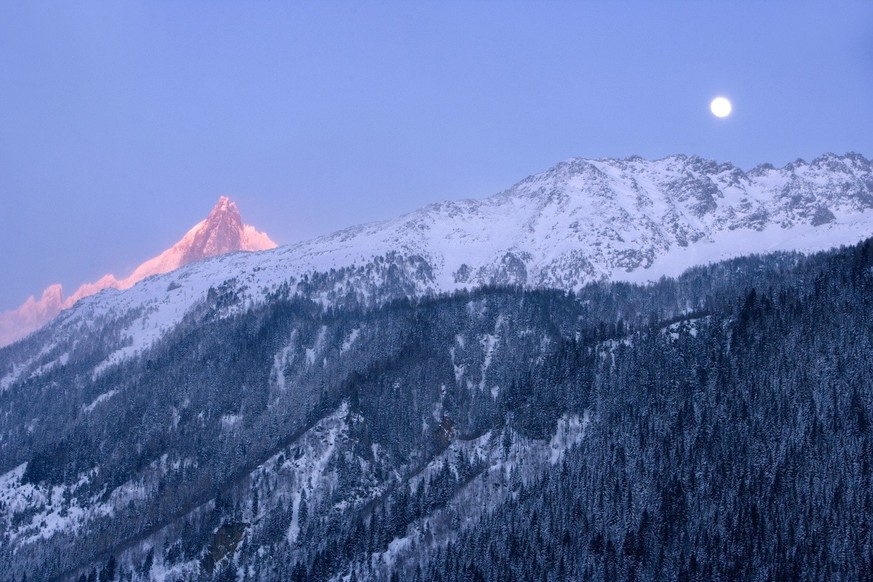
[{"xmin": 0, "ymin": 154, "xmax": 873, "ymax": 382}]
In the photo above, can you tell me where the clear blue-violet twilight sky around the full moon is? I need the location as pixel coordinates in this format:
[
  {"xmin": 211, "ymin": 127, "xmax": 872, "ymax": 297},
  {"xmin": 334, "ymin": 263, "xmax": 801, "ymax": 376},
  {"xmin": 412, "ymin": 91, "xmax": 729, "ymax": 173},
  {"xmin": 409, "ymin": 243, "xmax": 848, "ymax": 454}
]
[{"xmin": 0, "ymin": 0, "xmax": 873, "ymax": 310}]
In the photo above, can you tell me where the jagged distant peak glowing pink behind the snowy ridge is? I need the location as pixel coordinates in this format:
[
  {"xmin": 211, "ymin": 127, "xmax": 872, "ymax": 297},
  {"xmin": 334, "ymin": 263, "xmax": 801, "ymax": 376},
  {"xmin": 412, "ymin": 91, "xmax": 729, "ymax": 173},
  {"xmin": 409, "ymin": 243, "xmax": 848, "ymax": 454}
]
[{"xmin": 0, "ymin": 196, "xmax": 276, "ymax": 347}]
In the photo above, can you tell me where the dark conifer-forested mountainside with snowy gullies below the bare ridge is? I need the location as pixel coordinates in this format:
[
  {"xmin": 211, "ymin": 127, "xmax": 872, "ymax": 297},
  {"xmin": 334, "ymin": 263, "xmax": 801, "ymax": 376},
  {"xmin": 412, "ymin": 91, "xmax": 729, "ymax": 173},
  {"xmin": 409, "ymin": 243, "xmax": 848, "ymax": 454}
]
[{"xmin": 0, "ymin": 240, "xmax": 873, "ymax": 581}]
